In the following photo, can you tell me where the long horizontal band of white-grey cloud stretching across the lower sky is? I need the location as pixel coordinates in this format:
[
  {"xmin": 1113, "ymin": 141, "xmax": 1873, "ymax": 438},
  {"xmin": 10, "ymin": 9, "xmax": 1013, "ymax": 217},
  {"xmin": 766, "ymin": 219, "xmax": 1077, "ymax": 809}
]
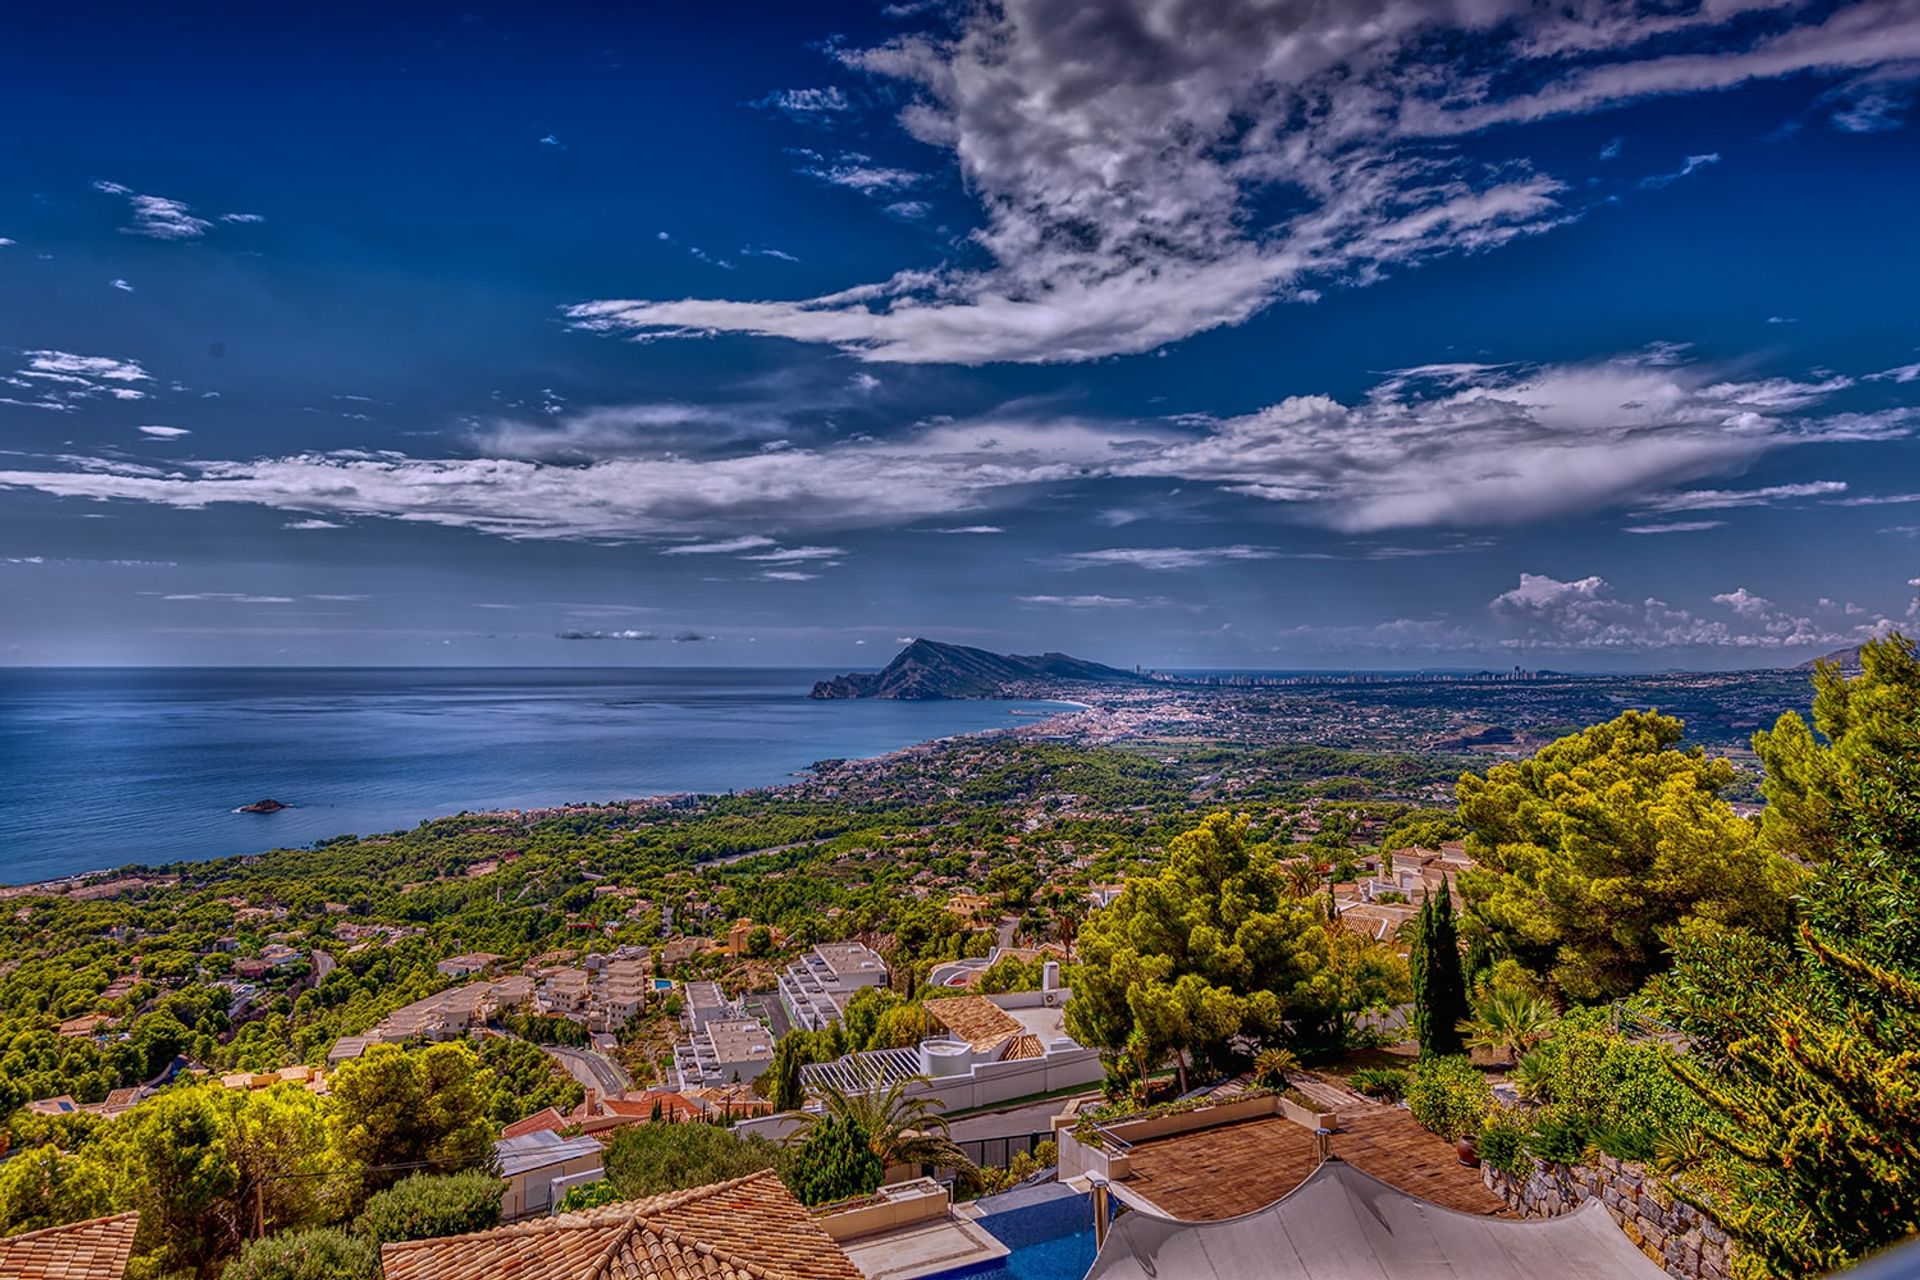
[{"xmin": 0, "ymin": 347, "xmax": 1920, "ymax": 537}]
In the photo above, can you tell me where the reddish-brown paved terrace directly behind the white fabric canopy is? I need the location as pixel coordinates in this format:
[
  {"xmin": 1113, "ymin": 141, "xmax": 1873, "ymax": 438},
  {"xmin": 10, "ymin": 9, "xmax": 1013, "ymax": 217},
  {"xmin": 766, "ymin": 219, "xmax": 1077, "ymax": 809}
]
[{"xmin": 1119, "ymin": 1105, "xmax": 1517, "ymax": 1222}]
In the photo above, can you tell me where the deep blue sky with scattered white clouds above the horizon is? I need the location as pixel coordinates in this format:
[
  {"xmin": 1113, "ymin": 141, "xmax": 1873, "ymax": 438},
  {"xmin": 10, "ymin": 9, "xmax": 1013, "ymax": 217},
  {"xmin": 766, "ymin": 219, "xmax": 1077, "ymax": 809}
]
[{"xmin": 0, "ymin": 0, "xmax": 1920, "ymax": 670}]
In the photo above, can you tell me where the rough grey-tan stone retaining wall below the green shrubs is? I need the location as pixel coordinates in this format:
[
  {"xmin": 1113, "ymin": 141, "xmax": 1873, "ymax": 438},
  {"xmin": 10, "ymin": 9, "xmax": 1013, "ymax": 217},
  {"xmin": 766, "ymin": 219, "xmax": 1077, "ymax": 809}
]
[{"xmin": 1480, "ymin": 1155, "xmax": 1734, "ymax": 1280}]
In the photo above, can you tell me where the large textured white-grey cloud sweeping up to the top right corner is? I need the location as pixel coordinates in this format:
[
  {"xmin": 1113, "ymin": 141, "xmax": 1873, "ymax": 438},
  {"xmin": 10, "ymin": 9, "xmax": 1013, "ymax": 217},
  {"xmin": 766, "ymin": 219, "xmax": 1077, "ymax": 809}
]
[{"xmin": 570, "ymin": 0, "xmax": 1920, "ymax": 365}]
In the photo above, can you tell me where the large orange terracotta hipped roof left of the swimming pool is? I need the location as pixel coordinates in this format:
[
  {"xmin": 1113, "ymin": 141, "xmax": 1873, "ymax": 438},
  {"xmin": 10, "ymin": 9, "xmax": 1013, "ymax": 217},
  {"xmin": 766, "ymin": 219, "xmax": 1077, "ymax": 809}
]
[{"xmin": 380, "ymin": 1171, "xmax": 860, "ymax": 1280}]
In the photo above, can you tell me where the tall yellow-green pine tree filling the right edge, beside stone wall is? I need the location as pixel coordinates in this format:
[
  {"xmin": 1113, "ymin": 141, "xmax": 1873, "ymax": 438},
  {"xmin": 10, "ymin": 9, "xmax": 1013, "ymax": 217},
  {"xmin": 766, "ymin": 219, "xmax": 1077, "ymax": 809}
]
[{"xmin": 1659, "ymin": 635, "xmax": 1920, "ymax": 1276}]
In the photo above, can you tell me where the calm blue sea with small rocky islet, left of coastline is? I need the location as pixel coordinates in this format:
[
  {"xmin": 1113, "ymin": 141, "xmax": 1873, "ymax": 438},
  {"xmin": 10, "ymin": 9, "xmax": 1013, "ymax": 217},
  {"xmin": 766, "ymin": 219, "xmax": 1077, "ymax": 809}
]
[{"xmin": 0, "ymin": 668, "xmax": 1060, "ymax": 883}]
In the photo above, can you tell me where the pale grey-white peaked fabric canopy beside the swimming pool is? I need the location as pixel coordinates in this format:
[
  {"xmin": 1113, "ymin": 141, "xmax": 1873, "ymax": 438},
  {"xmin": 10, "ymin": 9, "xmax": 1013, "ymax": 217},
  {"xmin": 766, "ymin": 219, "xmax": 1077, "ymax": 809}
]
[{"xmin": 1087, "ymin": 1159, "xmax": 1667, "ymax": 1280}]
